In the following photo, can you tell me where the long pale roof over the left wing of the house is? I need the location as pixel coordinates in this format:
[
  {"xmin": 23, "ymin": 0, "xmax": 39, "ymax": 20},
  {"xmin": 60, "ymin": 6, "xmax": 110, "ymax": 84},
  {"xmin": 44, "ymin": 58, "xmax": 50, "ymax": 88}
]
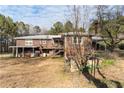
[{"xmin": 14, "ymin": 35, "xmax": 61, "ymax": 39}]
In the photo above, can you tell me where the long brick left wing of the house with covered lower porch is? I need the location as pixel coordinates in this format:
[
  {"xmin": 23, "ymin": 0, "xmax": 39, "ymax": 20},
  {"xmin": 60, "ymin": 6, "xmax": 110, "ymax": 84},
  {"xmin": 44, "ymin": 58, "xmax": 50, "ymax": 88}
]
[{"xmin": 10, "ymin": 35, "xmax": 63, "ymax": 57}]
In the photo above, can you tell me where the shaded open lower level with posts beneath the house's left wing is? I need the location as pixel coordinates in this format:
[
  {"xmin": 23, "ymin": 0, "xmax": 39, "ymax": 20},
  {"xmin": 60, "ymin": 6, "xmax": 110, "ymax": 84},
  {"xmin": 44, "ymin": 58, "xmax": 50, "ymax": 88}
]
[{"xmin": 10, "ymin": 46, "xmax": 64, "ymax": 57}]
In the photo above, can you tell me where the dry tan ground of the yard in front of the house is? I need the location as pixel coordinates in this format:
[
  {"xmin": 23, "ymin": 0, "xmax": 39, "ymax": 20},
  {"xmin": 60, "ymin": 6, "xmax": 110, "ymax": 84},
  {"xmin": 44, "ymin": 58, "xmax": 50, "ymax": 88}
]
[{"xmin": 0, "ymin": 58, "xmax": 124, "ymax": 88}]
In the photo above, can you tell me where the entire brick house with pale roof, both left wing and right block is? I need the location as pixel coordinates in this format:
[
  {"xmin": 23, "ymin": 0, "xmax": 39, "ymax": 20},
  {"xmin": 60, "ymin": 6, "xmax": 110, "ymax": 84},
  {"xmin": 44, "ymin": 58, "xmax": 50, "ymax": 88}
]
[{"xmin": 10, "ymin": 32, "xmax": 107, "ymax": 58}]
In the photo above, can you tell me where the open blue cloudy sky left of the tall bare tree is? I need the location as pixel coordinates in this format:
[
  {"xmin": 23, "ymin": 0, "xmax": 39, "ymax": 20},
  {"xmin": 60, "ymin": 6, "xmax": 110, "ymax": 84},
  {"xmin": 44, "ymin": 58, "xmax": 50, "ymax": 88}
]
[{"xmin": 0, "ymin": 5, "xmax": 68, "ymax": 29}]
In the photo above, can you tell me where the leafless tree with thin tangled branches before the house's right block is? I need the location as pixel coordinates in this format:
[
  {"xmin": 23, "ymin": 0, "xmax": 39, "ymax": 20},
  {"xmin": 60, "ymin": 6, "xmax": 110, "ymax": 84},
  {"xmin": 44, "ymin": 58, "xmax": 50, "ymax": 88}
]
[{"xmin": 67, "ymin": 5, "xmax": 90, "ymax": 69}]
